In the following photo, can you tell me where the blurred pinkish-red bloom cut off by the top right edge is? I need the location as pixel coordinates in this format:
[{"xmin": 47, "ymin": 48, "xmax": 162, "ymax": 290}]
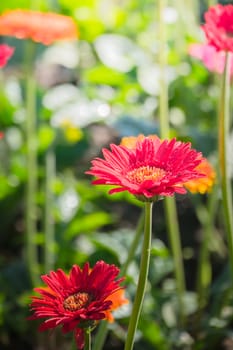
[{"xmin": 202, "ymin": 4, "xmax": 233, "ymax": 52}]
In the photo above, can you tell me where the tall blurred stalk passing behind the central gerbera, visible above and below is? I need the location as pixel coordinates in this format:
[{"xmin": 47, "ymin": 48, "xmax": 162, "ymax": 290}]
[{"xmin": 158, "ymin": 0, "xmax": 186, "ymax": 326}]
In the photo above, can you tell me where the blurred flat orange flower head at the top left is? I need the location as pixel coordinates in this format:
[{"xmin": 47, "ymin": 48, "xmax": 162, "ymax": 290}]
[{"xmin": 0, "ymin": 9, "xmax": 78, "ymax": 45}]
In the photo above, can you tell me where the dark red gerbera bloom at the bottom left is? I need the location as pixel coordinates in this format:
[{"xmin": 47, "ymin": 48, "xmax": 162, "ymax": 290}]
[{"xmin": 29, "ymin": 261, "xmax": 123, "ymax": 349}]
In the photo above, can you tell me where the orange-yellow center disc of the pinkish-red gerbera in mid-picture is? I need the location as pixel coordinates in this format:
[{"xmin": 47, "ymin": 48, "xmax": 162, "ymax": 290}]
[{"xmin": 127, "ymin": 165, "xmax": 166, "ymax": 184}]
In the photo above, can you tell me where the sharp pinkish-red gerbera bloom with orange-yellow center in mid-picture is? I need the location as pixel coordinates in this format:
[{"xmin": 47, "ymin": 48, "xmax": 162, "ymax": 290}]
[{"xmin": 86, "ymin": 136, "xmax": 206, "ymax": 200}]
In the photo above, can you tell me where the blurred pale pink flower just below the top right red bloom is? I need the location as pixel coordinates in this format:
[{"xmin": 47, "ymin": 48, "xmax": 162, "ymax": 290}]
[{"xmin": 188, "ymin": 44, "xmax": 233, "ymax": 76}]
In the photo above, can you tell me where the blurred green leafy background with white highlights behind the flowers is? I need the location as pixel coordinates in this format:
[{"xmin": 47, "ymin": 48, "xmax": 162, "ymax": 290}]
[{"xmin": 0, "ymin": 0, "xmax": 233, "ymax": 350}]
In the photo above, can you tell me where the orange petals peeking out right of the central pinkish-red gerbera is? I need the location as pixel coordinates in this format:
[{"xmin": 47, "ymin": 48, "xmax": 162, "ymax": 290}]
[{"xmin": 184, "ymin": 158, "xmax": 216, "ymax": 194}]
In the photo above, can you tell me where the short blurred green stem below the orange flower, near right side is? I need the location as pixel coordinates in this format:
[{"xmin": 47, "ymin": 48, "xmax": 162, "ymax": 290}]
[{"xmin": 196, "ymin": 188, "xmax": 217, "ymax": 310}]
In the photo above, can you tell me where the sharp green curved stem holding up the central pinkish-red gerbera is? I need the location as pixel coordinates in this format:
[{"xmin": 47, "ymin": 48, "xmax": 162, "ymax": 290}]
[{"xmin": 125, "ymin": 202, "xmax": 153, "ymax": 350}]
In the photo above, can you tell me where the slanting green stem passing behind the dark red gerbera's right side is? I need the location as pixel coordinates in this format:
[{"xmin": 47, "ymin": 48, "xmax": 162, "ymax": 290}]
[{"xmin": 93, "ymin": 211, "xmax": 144, "ymax": 350}]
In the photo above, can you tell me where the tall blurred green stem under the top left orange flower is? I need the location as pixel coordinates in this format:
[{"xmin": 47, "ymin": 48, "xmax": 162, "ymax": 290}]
[{"xmin": 25, "ymin": 41, "xmax": 39, "ymax": 286}]
